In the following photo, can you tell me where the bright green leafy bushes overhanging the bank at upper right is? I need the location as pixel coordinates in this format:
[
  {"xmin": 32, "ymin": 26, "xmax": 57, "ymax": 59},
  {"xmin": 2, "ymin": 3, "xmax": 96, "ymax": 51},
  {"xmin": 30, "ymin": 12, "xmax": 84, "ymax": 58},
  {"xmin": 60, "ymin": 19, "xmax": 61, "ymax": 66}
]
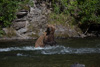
[{"xmin": 52, "ymin": 0, "xmax": 100, "ymax": 25}]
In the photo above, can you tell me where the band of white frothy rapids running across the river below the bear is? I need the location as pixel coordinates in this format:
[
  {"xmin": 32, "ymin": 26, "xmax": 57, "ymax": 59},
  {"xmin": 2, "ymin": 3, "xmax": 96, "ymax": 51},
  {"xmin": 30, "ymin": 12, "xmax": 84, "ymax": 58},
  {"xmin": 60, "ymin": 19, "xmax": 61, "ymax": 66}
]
[{"xmin": 0, "ymin": 45, "xmax": 100, "ymax": 56}]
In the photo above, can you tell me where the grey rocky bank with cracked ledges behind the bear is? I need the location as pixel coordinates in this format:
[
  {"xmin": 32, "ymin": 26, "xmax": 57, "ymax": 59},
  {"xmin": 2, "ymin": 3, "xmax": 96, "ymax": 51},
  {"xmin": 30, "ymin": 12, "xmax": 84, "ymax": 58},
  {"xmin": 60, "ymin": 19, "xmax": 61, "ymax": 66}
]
[{"xmin": 1, "ymin": 0, "xmax": 85, "ymax": 39}]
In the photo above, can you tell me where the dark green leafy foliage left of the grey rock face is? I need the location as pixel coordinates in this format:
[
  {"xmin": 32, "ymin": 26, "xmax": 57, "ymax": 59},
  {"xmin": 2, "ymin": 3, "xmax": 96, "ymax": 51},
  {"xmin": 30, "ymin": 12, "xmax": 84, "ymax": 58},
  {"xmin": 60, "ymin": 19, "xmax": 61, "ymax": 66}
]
[{"xmin": 0, "ymin": 0, "xmax": 32, "ymax": 27}]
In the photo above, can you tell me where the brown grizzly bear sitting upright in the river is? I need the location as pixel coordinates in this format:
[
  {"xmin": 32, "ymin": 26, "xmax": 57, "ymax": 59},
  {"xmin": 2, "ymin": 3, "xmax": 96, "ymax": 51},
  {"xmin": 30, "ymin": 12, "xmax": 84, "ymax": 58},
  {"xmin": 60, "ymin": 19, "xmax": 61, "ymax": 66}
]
[{"xmin": 35, "ymin": 25, "xmax": 56, "ymax": 47}]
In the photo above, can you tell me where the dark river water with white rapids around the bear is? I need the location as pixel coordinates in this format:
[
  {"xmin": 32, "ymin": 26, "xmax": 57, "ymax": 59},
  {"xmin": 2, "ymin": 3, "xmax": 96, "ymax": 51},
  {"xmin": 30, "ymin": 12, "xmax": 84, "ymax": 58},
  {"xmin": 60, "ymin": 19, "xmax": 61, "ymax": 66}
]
[{"xmin": 0, "ymin": 38, "xmax": 100, "ymax": 67}]
